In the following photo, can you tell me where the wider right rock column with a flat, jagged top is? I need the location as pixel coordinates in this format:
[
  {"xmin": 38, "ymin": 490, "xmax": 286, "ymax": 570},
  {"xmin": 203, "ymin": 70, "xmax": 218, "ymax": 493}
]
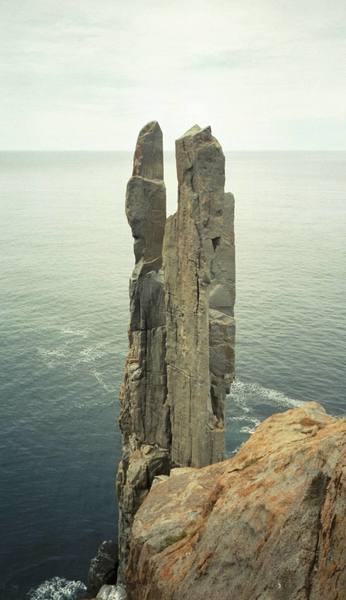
[{"xmin": 163, "ymin": 125, "xmax": 235, "ymax": 467}]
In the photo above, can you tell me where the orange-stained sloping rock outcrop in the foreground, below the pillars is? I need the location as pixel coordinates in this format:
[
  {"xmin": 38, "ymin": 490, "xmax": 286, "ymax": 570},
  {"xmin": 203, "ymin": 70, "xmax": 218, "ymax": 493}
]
[{"xmin": 126, "ymin": 402, "xmax": 346, "ymax": 600}]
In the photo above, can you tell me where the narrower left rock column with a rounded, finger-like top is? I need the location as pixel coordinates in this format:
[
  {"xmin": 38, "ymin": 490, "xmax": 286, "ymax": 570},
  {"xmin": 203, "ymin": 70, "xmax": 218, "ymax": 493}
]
[{"xmin": 117, "ymin": 122, "xmax": 171, "ymax": 577}]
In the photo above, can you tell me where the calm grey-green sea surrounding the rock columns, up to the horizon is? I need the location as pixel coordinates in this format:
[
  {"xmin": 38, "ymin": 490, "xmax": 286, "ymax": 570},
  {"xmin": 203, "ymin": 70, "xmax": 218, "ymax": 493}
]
[{"xmin": 0, "ymin": 153, "xmax": 346, "ymax": 600}]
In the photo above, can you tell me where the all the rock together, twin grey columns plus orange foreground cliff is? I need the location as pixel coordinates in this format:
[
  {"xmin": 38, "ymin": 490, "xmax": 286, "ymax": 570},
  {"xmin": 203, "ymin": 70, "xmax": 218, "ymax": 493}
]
[{"xmin": 112, "ymin": 122, "xmax": 346, "ymax": 600}]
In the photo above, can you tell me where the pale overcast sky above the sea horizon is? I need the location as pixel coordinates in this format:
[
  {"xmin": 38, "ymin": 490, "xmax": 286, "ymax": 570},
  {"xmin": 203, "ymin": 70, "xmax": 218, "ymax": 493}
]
[{"xmin": 0, "ymin": 0, "xmax": 346, "ymax": 150}]
